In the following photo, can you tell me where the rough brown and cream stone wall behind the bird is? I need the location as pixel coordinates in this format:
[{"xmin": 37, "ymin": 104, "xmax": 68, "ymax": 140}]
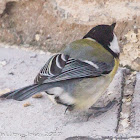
[{"xmin": 0, "ymin": 0, "xmax": 140, "ymax": 70}]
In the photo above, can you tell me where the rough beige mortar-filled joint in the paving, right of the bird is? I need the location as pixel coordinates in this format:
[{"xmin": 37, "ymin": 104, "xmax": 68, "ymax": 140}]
[{"xmin": 116, "ymin": 72, "xmax": 135, "ymax": 133}]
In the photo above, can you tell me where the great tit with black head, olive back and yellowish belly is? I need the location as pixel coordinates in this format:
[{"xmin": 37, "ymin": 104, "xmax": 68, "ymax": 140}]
[{"xmin": 0, "ymin": 23, "xmax": 120, "ymax": 111}]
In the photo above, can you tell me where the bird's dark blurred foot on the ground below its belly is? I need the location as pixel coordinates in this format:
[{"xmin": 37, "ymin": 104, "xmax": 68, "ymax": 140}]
[{"xmin": 87, "ymin": 99, "xmax": 117, "ymax": 120}]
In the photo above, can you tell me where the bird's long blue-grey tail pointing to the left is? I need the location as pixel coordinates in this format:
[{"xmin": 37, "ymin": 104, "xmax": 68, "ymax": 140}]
[{"xmin": 0, "ymin": 84, "xmax": 48, "ymax": 101}]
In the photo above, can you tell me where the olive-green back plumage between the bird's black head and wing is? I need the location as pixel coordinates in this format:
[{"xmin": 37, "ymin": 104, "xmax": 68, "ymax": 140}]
[{"xmin": 62, "ymin": 38, "xmax": 113, "ymax": 62}]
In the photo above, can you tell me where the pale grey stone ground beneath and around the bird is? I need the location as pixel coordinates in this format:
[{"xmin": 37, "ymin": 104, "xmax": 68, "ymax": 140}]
[{"xmin": 0, "ymin": 45, "xmax": 140, "ymax": 140}]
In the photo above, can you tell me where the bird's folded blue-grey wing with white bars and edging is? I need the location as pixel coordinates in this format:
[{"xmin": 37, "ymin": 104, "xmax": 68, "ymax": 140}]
[{"xmin": 35, "ymin": 54, "xmax": 113, "ymax": 84}]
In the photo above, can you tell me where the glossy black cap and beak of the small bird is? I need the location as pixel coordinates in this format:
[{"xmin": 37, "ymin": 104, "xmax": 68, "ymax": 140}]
[{"xmin": 83, "ymin": 23, "xmax": 119, "ymax": 57}]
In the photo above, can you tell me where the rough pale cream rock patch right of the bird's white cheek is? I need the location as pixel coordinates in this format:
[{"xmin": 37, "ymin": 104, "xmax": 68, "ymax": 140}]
[{"xmin": 120, "ymin": 29, "xmax": 140, "ymax": 70}]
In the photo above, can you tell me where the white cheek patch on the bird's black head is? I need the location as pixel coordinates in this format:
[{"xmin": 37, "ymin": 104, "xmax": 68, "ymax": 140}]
[{"xmin": 109, "ymin": 34, "xmax": 120, "ymax": 53}]
